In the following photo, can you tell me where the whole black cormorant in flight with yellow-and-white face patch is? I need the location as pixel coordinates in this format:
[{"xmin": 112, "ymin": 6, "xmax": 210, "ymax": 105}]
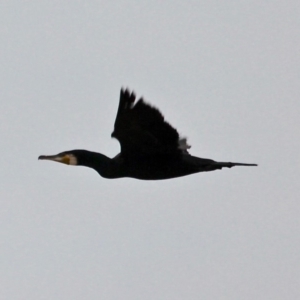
[{"xmin": 39, "ymin": 89, "xmax": 257, "ymax": 180}]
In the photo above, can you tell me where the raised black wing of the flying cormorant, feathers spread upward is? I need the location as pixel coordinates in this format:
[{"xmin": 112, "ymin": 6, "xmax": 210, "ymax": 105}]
[{"xmin": 112, "ymin": 89, "xmax": 190, "ymax": 156}]
